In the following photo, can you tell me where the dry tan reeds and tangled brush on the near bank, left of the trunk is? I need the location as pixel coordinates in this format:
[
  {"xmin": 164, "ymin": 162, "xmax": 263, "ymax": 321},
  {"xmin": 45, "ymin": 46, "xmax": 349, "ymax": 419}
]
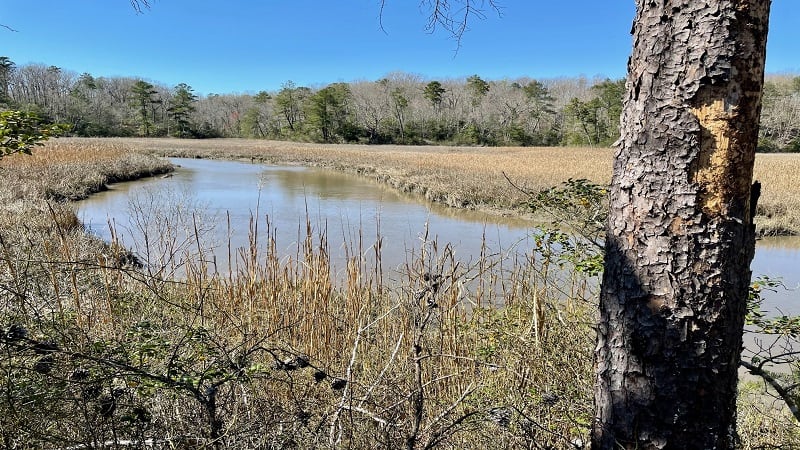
[{"xmin": 0, "ymin": 195, "xmax": 591, "ymax": 448}]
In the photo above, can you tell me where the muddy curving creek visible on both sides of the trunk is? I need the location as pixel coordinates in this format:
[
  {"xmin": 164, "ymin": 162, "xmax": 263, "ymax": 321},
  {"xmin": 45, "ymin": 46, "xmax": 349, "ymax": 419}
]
[{"xmin": 77, "ymin": 158, "xmax": 800, "ymax": 314}]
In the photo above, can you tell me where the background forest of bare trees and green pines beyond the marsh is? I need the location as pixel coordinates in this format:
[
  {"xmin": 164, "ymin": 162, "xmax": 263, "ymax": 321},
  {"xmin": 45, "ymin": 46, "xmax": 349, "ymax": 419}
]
[{"xmin": 0, "ymin": 57, "xmax": 800, "ymax": 152}]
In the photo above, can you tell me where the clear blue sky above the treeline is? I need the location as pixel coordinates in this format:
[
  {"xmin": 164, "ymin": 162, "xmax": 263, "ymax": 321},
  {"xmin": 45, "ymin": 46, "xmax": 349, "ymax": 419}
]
[{"xmin": 0, "ymin": 0, "xmax": 800, "ymax": 94}]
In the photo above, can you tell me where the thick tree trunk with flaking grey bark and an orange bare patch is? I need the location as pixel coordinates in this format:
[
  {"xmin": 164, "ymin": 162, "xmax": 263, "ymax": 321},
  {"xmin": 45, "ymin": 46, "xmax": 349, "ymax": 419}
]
[{"xmin": 592, "ymin": 0, "xmax": 770, "ymax": 449}]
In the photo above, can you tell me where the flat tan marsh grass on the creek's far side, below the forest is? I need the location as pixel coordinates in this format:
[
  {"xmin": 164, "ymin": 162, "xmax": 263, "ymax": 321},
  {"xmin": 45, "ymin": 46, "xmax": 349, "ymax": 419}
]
[{"xmin": 66, "ymin": 139, "xmax": 800, "ymax": 235}]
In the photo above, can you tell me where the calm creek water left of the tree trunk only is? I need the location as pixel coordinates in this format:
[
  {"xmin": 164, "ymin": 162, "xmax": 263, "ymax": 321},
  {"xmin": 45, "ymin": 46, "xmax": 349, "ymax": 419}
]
[{"xmin": 78, "ymin": 159, "xmax": 531, "ymax": 278}]
